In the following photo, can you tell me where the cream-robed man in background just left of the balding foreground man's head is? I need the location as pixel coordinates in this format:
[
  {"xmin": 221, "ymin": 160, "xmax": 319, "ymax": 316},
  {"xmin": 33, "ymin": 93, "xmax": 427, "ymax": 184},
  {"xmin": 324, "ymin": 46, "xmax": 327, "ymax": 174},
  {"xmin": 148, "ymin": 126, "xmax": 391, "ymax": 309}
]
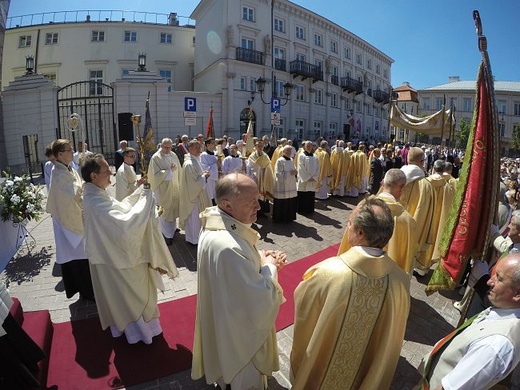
[{"xmin": 179, "ymin": 140, "xmax": 211, "ymax": 245}]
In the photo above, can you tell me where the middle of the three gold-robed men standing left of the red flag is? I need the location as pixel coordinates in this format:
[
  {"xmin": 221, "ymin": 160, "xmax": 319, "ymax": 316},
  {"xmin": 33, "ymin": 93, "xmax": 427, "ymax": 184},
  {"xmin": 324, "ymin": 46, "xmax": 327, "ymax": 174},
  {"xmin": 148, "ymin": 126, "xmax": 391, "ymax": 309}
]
[{"xmin": 399, "ymin": 147, "xmax": 434, "ymax": 276}]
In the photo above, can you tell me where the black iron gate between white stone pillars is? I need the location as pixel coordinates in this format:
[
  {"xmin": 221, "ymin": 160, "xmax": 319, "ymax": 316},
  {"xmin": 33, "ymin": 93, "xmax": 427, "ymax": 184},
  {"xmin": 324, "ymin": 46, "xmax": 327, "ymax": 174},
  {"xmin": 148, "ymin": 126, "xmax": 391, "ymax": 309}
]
[{"xmin": 57, "ymin": 81, "xmax": 117, "ymax": 165}]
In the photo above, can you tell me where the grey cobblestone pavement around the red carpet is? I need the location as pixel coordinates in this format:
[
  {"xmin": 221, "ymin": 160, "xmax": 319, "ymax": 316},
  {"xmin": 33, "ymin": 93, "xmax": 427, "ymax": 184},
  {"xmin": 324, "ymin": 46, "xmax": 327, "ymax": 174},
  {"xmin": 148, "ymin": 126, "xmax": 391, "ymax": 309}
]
[{"xmin": 0, "ymin": 177, "xmax": 460, "ymax": 390}]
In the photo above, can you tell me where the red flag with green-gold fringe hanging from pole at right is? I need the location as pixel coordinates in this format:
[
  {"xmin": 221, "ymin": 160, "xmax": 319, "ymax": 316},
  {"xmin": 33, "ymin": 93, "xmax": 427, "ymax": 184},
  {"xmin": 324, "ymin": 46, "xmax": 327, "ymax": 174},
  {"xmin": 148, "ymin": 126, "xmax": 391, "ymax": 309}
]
[{"xmin": 426, "ymin": 62, "xmax": 499, "ymax": 293}]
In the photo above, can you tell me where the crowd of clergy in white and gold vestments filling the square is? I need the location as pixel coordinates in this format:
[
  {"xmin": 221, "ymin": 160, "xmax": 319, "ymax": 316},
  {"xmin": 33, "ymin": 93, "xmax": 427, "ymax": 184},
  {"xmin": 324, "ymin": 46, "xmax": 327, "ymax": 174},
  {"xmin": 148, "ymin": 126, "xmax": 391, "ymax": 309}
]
[{"xmin": 19, "ymin": 134, "xmax": 520, "ymax": 389}]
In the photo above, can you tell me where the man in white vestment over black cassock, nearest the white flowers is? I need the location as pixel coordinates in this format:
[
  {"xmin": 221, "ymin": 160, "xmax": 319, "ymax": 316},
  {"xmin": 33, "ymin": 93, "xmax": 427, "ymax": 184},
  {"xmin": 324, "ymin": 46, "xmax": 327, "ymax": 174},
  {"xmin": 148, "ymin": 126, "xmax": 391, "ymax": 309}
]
[{"xmin": 47, "ymin": 139, "xmax": 94, "ymax": 301}]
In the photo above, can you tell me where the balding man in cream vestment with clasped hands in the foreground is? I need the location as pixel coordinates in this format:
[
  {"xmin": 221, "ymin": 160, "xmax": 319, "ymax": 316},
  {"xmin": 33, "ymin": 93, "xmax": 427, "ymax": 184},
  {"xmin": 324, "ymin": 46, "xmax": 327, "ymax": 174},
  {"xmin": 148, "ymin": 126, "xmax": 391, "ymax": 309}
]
[{"xmin": 191, "ymin": 174, "xmax": 286, "ymax": 389}]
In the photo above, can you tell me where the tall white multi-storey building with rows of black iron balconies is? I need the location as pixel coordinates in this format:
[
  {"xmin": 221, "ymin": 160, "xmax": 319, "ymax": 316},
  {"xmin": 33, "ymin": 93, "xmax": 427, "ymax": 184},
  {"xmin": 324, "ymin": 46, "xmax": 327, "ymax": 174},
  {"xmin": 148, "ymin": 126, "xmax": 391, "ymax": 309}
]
[{"xmin": 191, "ymin": 0, "xmax": 393, "ymax": 140}]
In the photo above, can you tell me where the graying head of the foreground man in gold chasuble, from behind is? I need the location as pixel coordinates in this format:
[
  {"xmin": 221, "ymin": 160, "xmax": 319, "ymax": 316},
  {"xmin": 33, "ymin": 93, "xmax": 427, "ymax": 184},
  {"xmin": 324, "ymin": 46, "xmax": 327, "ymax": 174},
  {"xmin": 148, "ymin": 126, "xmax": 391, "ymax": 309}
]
[{"xmin": 352, "ymin": 196, "xmax": 394, "ymax": 248}]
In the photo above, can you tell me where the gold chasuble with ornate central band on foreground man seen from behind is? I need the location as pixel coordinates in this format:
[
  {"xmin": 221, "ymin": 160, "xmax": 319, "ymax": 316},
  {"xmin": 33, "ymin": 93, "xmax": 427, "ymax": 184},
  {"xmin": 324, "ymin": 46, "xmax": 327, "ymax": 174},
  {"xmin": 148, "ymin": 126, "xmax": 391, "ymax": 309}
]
[{"xmin": 291, "ymin": 246, "xmax": 410, "ymax": 390}]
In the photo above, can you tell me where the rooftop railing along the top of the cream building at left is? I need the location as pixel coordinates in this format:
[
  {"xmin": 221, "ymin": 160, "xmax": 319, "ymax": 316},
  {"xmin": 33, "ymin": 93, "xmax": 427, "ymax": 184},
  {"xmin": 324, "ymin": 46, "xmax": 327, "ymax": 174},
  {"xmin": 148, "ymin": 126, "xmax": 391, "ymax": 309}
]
[{"xmin": 6, "ymin": 10, "xmax": 195, "ymax": 29}]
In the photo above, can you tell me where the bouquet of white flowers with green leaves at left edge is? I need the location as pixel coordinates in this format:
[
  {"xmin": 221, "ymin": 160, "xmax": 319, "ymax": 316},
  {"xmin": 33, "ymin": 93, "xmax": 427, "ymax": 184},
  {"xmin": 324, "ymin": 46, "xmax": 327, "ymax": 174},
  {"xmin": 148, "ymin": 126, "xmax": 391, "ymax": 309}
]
[{"xmin": 0, "ymin": 172, "xmax": 43, "ymax": 223}]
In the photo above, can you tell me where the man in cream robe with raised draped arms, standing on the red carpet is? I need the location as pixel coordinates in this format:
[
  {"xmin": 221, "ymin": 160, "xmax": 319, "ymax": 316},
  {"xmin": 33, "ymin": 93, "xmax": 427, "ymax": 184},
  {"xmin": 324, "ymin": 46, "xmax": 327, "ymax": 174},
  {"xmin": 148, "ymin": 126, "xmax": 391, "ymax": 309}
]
[{"xmin": 81, "ymin": 154, "xmax": 178, "ymax": 344}]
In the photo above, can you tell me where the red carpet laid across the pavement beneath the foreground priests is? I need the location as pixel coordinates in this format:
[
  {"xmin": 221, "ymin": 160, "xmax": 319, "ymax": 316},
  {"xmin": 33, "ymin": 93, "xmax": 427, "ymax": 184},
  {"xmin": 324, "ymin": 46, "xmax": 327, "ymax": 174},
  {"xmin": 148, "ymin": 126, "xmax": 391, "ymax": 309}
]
[{"xmin": 43, "ymin": 244, "xmax": 339, "ymax": 390}]
